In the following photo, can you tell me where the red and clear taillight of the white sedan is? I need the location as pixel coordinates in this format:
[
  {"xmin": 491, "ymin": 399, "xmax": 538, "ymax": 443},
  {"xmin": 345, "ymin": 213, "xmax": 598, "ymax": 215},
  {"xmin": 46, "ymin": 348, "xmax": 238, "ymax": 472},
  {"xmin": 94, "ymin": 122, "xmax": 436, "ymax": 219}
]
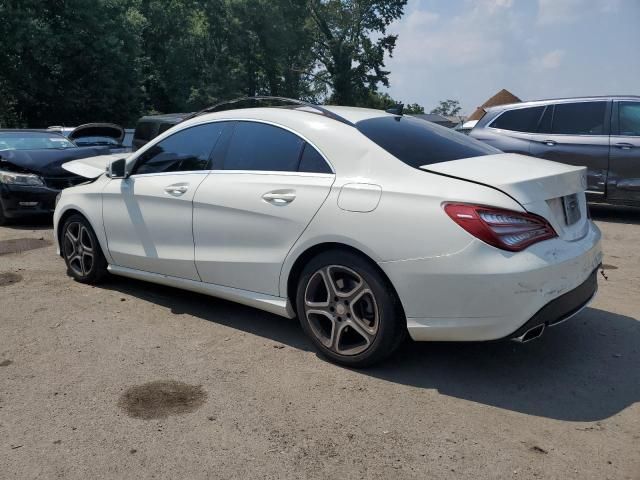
[{"xmin": 444, "ymin": 203, "xmax": 558, "ymax": 252}]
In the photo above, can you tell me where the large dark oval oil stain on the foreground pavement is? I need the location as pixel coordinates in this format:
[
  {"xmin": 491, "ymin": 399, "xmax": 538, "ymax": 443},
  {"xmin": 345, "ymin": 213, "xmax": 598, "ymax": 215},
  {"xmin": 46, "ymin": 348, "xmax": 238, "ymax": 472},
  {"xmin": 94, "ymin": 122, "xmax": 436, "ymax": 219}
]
[{"xmin": 118, "ymin": 380, "xmax": 207, "ymax": 420}]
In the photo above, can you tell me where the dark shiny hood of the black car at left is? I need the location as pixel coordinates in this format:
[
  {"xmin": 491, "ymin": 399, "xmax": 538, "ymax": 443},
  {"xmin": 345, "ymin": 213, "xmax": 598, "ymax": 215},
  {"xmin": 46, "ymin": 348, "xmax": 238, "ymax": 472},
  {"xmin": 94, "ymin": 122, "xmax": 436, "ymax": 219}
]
[{"xmin": 0, "ymin": 147, "xmax": 109, "ymax": 177}]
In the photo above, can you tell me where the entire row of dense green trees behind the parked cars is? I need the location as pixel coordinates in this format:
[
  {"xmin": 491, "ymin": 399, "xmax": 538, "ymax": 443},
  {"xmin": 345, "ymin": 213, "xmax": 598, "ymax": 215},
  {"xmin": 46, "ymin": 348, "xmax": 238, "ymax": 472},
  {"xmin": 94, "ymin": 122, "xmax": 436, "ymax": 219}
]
[{"xmin": 0, "ymin": 0, "xmax": 406, "ymax": 127}]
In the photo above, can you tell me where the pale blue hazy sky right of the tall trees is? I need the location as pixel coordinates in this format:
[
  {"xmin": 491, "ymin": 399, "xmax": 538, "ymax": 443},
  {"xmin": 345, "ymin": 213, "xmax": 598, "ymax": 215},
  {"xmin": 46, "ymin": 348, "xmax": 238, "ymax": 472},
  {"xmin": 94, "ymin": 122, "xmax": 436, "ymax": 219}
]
[{"xmin": 386, "ymin": 0, "xmax": 640, "ymax": 114}]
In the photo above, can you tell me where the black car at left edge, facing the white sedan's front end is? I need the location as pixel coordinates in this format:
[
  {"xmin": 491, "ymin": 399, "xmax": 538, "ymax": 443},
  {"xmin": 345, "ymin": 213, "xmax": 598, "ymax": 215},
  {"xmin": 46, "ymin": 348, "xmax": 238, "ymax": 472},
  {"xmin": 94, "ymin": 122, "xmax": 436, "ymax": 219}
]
[{"xmin": 0, "ymin": 130, "xmax": 109, "ymax": 225}]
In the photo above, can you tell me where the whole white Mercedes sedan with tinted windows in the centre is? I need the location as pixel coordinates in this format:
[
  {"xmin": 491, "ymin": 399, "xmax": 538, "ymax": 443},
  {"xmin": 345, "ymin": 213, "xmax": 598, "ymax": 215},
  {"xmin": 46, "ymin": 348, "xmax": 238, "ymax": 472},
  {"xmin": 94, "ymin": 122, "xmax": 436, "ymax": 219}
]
[{"xmin": 54, "ymin": 101, "xmax": 602, "ymax": 366}]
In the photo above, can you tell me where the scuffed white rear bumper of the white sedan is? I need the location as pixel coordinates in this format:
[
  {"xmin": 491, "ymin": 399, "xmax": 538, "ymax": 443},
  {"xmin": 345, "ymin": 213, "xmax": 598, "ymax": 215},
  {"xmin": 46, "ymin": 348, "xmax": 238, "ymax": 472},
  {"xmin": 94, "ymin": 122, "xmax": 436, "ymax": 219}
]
[{"xmin": 380, "ymin": 222, "xmax": 602, "ymax": 341}]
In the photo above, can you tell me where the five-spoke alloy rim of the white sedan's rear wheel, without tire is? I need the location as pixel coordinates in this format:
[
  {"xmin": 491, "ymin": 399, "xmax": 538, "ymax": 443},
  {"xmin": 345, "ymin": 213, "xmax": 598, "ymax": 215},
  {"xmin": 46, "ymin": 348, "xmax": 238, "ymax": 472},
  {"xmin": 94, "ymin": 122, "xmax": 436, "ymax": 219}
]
[{"xmin": 304, "ymin": 265, "xmax": 380, "ymax": 355}]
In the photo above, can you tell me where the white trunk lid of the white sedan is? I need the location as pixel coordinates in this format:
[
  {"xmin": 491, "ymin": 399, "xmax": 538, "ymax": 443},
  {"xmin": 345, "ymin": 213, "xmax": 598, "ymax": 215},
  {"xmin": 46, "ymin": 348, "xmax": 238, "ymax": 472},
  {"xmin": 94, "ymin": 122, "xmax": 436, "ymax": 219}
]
[{"xmin": 420, "ymin": 153, "xmax": 588, "ymax": 240}]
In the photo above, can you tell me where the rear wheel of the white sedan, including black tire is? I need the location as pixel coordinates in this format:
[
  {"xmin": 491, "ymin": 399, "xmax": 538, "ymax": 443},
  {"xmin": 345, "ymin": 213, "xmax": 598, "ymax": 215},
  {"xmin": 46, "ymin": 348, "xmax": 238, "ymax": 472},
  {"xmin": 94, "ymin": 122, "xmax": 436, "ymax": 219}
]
[{"xmin": 296, "ymin": 250, "xmax": 406, "ymax": 368}]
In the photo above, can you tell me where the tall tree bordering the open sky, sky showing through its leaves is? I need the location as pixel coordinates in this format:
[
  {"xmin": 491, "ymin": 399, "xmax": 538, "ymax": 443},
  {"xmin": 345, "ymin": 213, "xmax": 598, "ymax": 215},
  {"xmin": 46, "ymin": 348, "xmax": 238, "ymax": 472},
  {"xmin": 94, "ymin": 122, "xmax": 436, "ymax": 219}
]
[{"xmin": 308, "ymin": 0, "xmax": 407, "ymax": 105}]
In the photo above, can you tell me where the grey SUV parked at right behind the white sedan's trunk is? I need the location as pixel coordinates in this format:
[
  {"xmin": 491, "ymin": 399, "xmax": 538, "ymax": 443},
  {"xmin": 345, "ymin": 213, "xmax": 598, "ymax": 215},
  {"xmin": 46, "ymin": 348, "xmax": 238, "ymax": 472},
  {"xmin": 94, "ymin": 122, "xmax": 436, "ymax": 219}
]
[{"xmin": 470, "ymin": 96, "xmax": 640, "ymax": 205}]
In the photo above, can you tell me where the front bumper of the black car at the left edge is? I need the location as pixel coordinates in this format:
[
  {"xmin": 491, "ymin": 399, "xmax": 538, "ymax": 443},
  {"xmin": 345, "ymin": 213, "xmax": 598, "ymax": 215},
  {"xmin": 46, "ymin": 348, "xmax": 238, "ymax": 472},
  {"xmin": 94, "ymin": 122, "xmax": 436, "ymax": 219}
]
[{"xmin": 0, "ymin": 184, "xmax": 60, "ymax": 218}]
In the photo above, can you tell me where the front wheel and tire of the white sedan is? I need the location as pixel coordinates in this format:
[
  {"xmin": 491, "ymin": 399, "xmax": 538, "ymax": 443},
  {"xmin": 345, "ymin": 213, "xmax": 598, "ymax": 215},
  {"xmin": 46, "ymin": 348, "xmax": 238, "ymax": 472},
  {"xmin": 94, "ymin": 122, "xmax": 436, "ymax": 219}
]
[{"xmin": 60, "ymin": 215, "xmax": 107, "ymax": 284}]
